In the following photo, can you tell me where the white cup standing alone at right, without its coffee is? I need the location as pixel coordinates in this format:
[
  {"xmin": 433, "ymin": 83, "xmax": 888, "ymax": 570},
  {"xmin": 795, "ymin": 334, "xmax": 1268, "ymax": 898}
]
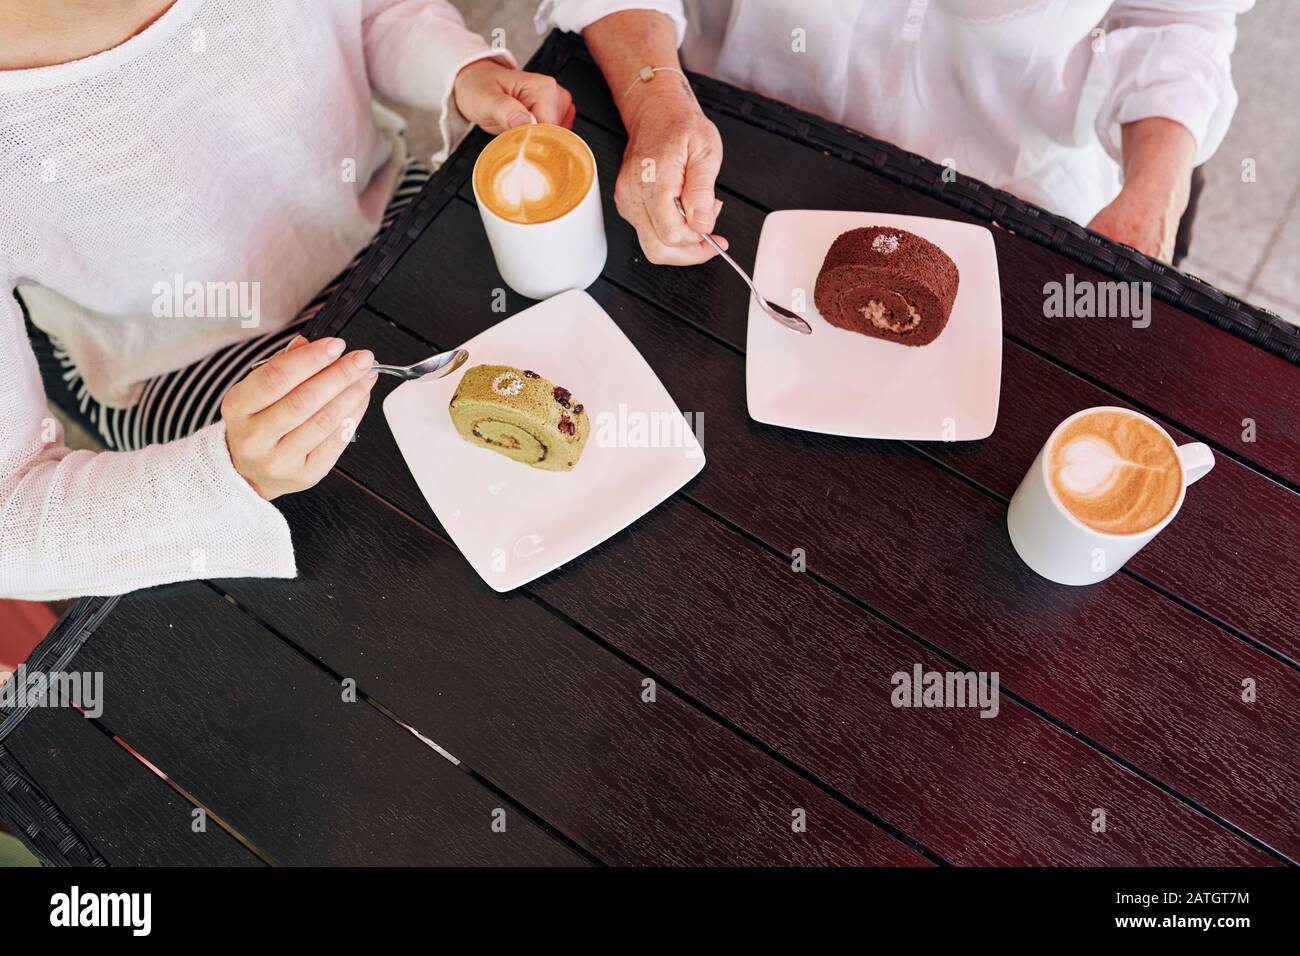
[{"xmin": 1006, "ymin": 406, "xmax": 1214, "ymax": 584}]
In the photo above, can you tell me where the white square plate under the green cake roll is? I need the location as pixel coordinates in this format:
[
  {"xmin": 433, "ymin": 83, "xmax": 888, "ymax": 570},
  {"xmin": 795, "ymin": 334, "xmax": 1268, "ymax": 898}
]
[{"xmin": 384, "ymin": 291, "xmax": 705, "ymax": 591}]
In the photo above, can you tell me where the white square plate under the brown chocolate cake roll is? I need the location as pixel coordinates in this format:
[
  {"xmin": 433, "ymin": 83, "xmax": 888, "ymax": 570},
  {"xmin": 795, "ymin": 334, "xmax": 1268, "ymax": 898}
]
[{"xmin": 745, "ymin": 209, "xmax": 1002, "ymax": 441}]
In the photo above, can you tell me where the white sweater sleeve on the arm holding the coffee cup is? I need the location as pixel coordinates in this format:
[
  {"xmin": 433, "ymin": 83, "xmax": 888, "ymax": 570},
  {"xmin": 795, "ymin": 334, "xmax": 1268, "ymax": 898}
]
[{"xmin": 361, "ymin": 0, "xmax": 517, "ymax": 163}]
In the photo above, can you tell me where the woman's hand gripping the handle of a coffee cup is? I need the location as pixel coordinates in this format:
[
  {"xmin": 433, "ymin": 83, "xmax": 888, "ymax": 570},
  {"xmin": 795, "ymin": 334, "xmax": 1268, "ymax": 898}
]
[{"xmin": 452, "ymin": 60, "xmax": 576, "ymax": 133}]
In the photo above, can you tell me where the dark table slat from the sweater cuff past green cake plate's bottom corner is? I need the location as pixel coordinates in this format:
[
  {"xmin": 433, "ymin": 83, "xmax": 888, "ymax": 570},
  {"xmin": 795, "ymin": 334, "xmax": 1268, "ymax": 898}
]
[{"xmin": 220, "ymin": 470, "xmax": 926, "ymax": 865}]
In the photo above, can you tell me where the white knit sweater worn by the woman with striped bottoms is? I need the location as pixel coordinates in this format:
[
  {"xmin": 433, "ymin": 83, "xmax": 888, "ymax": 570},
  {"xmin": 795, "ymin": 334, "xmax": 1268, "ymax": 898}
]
[{"xmin": 0, "ymin": 0, "xmax": 501, "ymax": 600}]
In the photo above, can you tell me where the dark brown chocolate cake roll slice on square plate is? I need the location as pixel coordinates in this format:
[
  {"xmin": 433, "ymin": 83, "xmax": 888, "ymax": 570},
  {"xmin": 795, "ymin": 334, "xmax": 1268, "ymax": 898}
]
[{"xmin": 813, "ymin": 226, "xmax": 958, "ymax": 345}]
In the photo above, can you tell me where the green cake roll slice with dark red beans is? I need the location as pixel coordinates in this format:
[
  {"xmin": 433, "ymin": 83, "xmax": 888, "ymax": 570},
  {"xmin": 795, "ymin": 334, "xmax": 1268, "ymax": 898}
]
[{"xmin": 450, "ymin": 365, "xmax": 592, "ymax": 471}]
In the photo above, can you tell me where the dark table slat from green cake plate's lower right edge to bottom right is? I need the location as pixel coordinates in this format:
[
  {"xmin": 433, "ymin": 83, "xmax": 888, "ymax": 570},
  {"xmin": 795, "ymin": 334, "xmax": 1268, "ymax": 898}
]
[{"xmin": 537, "ymin": 502, "xmax": 1274, "ymax": 866}]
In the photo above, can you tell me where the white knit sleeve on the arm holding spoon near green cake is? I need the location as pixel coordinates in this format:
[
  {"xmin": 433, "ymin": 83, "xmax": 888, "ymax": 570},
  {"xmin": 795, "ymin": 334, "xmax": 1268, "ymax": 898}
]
[{"xmin": 0, "ymin": 286, "xmax": 296, "ymax": 600}]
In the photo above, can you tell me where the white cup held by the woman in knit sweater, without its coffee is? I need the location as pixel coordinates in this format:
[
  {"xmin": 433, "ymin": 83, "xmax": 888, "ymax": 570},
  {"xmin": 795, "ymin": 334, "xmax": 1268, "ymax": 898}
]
[{"xmin": 471, "ymin": 124, "xmax": 607, "ymax": 299}]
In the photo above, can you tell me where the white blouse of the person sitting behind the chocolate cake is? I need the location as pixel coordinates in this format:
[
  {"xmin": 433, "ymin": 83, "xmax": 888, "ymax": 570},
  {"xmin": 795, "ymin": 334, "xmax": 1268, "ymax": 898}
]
[{"xmin": 537, "ymin": 0, "xmax": 1255, "ymax": 225}]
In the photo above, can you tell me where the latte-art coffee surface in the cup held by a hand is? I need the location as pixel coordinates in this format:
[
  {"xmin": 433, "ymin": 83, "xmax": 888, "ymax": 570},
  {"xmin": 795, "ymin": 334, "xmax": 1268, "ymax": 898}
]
[{"xmin": 475, "ymin": 124, "xmax": 595, "ymax": 224}]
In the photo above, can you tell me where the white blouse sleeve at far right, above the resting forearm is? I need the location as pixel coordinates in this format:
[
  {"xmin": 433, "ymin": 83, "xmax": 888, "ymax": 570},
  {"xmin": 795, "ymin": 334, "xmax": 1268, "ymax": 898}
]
[{"xmin": 1096, "ymin": 0, "xmax": 1255, "ymax": 165}]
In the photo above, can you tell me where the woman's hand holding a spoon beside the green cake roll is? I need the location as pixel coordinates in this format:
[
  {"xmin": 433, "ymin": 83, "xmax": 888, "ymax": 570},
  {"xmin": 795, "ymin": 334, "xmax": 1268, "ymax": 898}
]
[{"xmin": 221, "ymin": 336, "xmax": 378, "ymax": 501}]
